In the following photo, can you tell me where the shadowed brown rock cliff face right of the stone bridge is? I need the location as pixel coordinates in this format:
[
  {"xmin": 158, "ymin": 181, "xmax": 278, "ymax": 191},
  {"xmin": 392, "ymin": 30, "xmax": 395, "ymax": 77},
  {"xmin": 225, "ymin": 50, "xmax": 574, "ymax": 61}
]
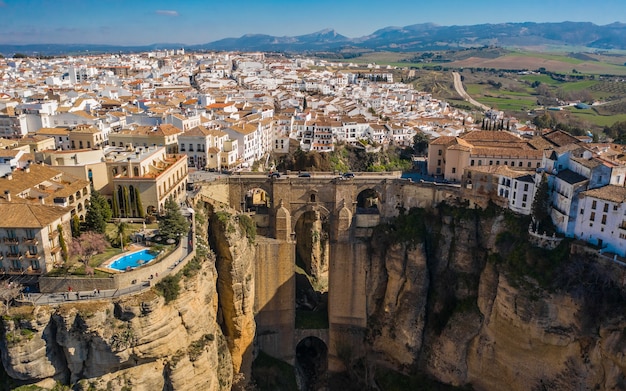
[{"xmin": 368, "ymin": 207, "xmax": 626, "ymax": 390}]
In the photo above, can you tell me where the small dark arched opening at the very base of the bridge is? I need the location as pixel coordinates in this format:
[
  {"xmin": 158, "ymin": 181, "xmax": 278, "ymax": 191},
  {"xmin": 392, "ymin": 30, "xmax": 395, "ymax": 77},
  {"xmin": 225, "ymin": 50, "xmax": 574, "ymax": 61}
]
[{"xmin": 296, "ymin": 336, "xmax": 328, "ymax": 391}]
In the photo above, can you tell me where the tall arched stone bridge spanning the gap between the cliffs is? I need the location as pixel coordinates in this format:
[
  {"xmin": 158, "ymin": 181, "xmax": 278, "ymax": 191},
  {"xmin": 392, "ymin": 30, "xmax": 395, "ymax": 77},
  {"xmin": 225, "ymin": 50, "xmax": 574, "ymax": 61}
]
[{"xmin": 201, "ymin": 172, "xmax": 460, "ymax": 371}]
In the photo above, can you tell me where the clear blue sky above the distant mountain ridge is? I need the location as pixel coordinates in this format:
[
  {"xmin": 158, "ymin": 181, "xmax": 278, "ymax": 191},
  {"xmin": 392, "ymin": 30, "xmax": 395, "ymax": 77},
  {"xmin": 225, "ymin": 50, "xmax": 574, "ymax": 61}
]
[{"xmin": 0, "ymin": 0, "xmax": 626, "ymax": 45}]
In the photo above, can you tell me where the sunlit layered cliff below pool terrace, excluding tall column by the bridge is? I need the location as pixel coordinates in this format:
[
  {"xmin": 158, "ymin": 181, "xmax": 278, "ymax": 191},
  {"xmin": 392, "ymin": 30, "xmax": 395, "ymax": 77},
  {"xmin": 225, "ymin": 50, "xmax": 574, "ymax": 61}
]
[{"xmin": 2, "ymin": 254, "xmax": 233, "ymax": 391}]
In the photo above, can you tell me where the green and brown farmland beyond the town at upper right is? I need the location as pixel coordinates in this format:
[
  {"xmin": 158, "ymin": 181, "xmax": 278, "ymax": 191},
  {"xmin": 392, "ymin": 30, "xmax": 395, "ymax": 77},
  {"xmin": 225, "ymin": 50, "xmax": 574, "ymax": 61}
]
[{"xmin": 320, "ymin": 47, "xmax": 626, "ymax": 131}]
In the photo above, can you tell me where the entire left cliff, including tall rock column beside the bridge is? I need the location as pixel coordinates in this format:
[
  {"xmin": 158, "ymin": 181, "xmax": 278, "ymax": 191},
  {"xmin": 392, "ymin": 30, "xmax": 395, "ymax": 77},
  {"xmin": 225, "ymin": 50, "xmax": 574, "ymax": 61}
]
[{"xmin": 0, "ymin": 204, "xmax": 255, "ymax": 391}]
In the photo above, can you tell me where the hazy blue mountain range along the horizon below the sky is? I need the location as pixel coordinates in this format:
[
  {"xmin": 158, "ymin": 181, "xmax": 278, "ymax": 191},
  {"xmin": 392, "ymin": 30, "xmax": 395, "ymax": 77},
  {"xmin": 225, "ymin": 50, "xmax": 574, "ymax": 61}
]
[{"xmin": 0, "ymin": 22, "xmax": 626, "ymax": 56}]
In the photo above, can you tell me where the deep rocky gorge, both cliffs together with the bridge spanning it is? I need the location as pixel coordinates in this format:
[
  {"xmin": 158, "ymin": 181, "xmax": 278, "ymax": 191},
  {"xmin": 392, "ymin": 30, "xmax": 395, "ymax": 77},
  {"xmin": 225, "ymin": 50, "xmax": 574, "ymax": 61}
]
[{"xmin": 0, "ymin": 178, "xmax": 626, "ymax": 390}]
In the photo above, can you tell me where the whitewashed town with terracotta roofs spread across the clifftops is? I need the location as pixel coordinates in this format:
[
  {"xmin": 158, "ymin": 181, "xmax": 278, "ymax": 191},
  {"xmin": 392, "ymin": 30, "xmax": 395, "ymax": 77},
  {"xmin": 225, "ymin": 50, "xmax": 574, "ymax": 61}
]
[{"xmin": 0, "ymin": 49, "xmax": 626, "ymax": 282}]
